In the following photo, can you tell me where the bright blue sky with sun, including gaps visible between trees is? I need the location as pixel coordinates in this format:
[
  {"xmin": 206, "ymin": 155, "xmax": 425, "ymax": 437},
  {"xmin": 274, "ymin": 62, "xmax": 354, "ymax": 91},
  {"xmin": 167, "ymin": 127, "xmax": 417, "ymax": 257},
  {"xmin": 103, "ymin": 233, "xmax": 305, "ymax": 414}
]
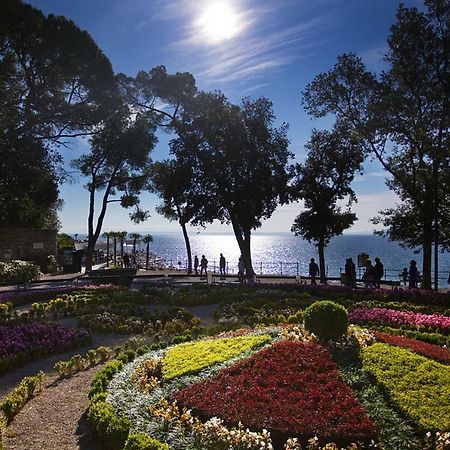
[{"xmin": 29, "ymin": 0, "xmax": 423, "ymax": 233}]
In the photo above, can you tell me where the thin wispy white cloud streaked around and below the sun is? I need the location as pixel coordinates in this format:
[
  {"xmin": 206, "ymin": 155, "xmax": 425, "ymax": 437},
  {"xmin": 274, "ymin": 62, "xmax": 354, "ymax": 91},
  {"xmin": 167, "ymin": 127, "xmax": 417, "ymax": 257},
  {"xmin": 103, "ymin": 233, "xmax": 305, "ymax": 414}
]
[{"xmin": 152, "ymin": 0, "xmax": 330, "ymax": 88}]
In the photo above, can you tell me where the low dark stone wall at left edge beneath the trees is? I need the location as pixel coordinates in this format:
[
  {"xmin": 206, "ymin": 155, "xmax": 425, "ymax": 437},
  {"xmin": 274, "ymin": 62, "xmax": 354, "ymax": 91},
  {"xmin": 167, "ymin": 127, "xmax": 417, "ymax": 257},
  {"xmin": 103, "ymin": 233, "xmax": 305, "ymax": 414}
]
[{"xmin": 0, "ymin": 228, "xmax": 56, "ymax": 262}]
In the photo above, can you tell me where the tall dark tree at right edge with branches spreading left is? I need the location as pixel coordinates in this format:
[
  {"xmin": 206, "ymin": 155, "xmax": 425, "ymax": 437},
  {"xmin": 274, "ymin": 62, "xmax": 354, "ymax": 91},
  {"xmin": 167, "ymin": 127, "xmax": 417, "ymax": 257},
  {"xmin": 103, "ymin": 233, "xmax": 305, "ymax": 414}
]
[{"xmin": 303, "ymin": 0, "xmax": 450, "ymax": 288}]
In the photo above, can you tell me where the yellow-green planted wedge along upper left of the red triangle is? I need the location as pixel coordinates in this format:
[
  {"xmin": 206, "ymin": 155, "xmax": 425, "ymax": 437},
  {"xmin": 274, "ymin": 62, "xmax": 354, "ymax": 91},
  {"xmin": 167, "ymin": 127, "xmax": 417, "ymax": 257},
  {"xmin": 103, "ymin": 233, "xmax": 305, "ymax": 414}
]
[{"xmin": 164, "ymin": 334, "xmax": 272, "ymax": 380}]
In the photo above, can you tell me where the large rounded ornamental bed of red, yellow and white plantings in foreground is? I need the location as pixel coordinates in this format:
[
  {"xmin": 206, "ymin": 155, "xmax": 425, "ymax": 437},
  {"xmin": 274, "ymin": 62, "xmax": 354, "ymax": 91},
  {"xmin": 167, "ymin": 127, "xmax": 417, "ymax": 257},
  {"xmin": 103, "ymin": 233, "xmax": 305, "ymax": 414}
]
[{"xmin": 89, "ymin": 325, "xmax": 450, "ymax": 450}]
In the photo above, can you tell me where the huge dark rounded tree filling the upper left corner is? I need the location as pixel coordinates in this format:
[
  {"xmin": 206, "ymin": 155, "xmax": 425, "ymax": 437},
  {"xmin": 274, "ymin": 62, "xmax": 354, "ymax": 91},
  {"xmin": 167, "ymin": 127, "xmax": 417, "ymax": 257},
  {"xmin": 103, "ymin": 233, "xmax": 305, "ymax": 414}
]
[{"xmin": 0, "ymin": 0, "xmax": 118, "ymax": 227}]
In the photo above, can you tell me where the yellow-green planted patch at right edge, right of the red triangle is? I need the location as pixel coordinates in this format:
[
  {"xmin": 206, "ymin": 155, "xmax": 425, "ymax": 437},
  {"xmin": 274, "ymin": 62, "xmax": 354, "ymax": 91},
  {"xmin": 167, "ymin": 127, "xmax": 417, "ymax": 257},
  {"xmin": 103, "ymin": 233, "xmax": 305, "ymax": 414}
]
[{"xmin": 362, "ymin": 343, "xmax": 450, "ymax": 431}]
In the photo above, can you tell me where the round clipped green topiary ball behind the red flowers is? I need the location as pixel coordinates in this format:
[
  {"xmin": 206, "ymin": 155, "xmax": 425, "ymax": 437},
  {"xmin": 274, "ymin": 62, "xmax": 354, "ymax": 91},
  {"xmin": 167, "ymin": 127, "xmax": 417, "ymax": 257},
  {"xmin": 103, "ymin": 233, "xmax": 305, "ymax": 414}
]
[{"xmin": 303, "ymin": 300, "xmax": 348, "ymax": 341}]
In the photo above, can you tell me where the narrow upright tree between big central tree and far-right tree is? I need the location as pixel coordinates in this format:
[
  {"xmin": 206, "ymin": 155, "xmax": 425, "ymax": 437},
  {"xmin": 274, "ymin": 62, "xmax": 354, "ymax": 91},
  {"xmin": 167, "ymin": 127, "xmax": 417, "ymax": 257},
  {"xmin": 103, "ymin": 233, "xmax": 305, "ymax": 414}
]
[{"xmin": 291, "ymin": 125, "xmax": 363, "ymax": 282}]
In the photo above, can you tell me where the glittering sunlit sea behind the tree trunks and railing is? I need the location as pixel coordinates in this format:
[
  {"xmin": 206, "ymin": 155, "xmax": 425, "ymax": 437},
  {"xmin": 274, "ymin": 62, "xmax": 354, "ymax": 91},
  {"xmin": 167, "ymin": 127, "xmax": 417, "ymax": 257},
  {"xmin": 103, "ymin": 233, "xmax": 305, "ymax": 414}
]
[{"xmin": 127, "ymin": 233, "xmax": 450, "ymax": 287}]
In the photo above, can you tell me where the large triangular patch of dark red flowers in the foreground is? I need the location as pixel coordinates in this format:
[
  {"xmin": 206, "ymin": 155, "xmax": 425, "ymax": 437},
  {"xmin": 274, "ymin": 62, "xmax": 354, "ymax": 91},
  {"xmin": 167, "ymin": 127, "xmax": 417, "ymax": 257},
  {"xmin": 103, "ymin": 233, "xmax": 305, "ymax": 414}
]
[{"xmin": 173, "ymin": 341, "xmax": 375, "ymax": 443}]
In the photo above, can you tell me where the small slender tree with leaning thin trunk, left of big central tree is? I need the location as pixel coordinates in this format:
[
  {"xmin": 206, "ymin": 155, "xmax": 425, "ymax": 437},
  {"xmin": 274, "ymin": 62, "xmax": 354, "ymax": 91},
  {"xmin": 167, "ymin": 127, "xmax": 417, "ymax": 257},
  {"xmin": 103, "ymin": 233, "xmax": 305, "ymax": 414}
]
[{"xmin": 151, "ymin": 160, "xmax": 194, "ymax": 274}]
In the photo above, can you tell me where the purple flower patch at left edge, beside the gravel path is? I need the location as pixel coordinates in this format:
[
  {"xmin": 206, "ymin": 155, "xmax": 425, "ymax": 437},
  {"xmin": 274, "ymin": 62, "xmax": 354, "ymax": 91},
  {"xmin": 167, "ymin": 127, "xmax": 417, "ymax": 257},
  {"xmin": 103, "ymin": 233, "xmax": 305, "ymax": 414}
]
[{"xmin": 0, "ymin": 323, "xmax": 89, "ymax": 373}]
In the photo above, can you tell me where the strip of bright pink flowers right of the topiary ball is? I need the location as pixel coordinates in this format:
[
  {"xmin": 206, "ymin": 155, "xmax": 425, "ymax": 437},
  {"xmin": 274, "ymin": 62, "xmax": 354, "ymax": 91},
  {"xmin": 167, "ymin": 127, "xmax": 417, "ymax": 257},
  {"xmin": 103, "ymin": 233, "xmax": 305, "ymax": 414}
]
[{"xmin": 349, "ymin": 308, "xmax": 450, "ymax": 334}]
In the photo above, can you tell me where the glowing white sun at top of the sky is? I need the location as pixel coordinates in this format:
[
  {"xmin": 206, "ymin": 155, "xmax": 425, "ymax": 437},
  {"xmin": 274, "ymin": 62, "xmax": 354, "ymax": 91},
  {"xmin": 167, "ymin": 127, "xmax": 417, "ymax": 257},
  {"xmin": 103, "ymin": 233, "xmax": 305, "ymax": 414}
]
[{"xmin": 197, "ymin": 1, "xmax": 242, "ymax": 43}]
